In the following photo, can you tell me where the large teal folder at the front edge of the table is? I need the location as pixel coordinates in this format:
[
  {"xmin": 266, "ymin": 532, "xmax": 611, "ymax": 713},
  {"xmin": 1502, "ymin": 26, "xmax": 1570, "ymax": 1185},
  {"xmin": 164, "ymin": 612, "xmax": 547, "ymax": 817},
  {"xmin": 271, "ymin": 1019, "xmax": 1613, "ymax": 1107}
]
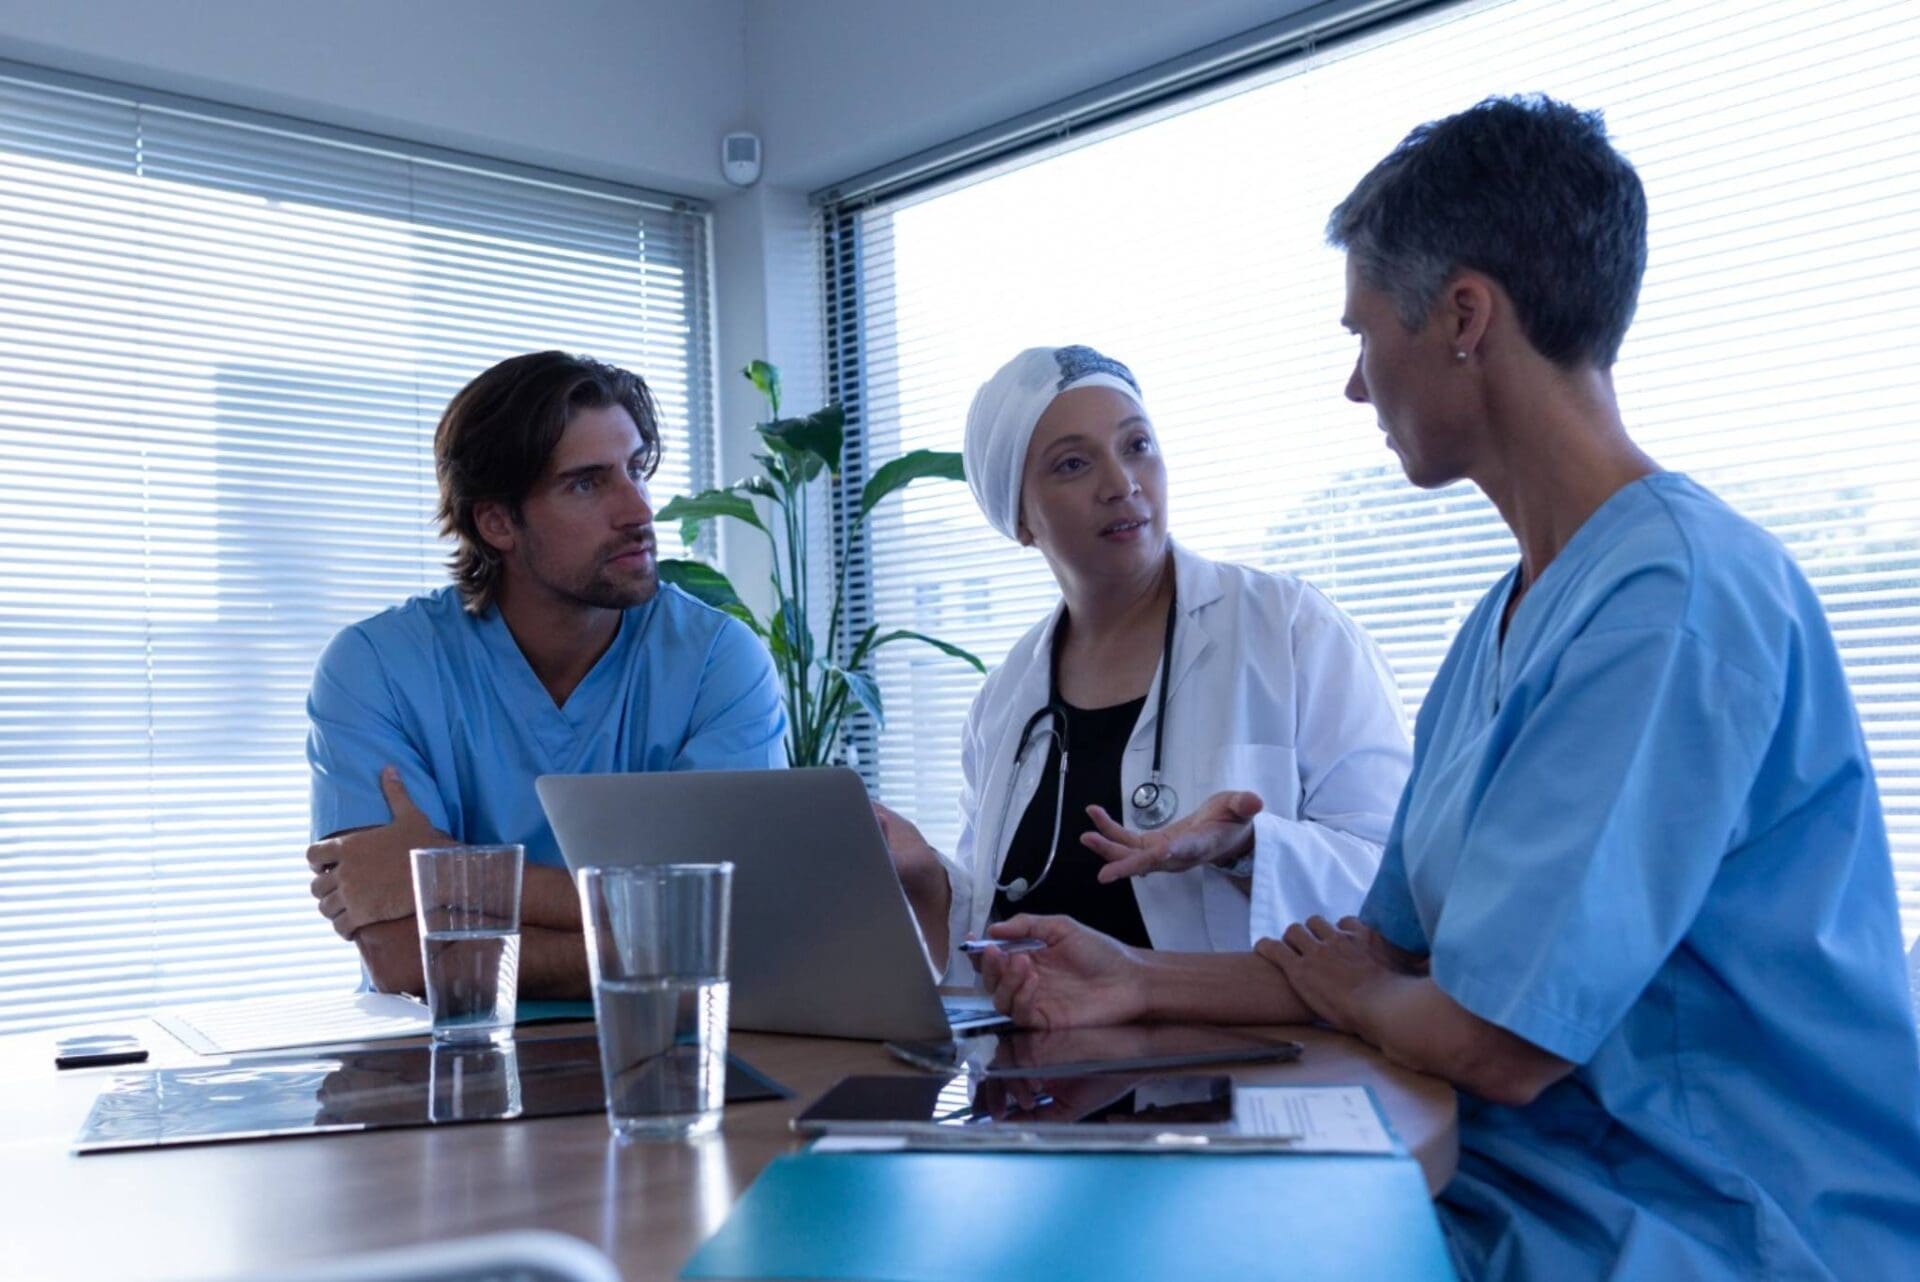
[{"xmin": 680, "ymin": 1151, "xmax": 1455, "ymax": 1282}]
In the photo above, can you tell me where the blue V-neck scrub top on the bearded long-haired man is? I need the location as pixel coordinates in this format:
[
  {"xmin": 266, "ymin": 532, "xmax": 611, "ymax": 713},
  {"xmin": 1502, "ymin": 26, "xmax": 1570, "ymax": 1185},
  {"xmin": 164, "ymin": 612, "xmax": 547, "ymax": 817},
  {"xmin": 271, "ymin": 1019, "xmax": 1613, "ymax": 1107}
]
[{"xmin": 307, "ymin": 585, "xmax": 787, "ymax": 866}]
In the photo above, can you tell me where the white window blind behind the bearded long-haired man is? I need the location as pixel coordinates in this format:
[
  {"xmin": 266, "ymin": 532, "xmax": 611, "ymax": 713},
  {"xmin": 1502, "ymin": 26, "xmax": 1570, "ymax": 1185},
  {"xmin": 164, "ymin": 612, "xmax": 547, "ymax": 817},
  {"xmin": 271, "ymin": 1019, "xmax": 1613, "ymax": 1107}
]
[{"xmin": 0, "ymin": 69, "xmax": 712, "ymax": 1033}]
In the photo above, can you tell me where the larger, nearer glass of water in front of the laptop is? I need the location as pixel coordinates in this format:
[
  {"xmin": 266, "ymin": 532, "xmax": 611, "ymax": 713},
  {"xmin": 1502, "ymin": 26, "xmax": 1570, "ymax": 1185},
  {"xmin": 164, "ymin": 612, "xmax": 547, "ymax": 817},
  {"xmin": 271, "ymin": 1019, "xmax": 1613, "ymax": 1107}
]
[{"xmin": 580, "ymin": 864, "xmax": 733, "ymax": 1140}]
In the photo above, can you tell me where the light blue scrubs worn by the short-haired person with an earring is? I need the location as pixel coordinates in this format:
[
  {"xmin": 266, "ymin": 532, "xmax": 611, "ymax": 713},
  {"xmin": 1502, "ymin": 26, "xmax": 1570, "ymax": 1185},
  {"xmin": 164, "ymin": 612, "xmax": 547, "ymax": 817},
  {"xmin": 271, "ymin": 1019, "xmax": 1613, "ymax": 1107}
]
[{"xmin": 1361, "ymin": 474, "xmax": 1920, "ymax": 1280}]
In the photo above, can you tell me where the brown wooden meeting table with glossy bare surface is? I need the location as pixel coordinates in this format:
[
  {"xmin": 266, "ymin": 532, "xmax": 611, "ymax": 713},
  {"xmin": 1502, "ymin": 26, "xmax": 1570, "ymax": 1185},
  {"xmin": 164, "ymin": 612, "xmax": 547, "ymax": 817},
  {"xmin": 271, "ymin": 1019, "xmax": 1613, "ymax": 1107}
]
[{"xmin": 0, "ymin": 1023, "xmax": 1457, "ymax": 1282}]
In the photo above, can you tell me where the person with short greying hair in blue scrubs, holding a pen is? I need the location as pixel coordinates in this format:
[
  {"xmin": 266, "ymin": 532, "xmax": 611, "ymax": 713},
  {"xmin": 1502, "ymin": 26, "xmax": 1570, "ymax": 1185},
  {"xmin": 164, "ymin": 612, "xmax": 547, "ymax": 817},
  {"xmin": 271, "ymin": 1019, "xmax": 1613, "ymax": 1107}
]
[{"xmin": 981, "ymin": 100, "xmax": 1920, "ymax": 1282}]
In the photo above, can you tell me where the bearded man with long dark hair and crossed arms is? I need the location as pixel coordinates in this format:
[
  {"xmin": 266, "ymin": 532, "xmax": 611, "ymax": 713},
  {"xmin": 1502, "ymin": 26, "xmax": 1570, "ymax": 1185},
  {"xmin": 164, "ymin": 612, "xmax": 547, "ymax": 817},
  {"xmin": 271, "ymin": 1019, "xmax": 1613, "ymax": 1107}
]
[{"xmin": 307, "ymin": 351, "xmax": 785, "ymax": 998}]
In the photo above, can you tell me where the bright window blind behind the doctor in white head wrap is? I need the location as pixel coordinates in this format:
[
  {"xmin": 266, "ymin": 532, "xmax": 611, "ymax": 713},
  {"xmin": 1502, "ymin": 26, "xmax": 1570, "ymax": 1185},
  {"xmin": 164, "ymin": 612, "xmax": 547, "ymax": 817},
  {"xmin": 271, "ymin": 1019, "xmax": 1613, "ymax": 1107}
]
[{"xmin": 822, "ymin": 0, "xmax": 1920, "ymax": 938}]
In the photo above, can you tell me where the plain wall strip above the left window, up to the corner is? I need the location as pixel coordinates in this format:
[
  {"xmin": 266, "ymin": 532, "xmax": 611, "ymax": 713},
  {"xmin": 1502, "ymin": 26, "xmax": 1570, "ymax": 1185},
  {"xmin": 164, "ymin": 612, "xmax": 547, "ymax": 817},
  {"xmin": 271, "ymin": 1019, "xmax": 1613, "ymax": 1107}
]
[{"xmin": 0, "ymin": 0, "xmax": 747, "ymax": 196}]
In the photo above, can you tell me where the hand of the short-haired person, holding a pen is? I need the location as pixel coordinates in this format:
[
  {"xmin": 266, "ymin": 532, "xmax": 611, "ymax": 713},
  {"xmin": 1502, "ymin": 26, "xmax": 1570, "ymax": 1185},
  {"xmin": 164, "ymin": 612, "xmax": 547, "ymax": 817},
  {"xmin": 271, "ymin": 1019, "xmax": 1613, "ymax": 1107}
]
[{"xmin": 973, "ymin": 914, "xmax": 1146, "ymax": 1029}]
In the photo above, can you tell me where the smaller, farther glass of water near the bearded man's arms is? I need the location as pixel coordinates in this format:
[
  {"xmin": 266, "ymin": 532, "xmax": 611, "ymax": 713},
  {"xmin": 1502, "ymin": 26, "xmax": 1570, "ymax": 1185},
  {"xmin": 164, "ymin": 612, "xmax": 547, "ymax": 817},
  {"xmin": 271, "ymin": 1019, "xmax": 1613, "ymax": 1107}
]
[{"xmin": 413, "ymin": 846, "xmax": 526, "ymax": 1042}]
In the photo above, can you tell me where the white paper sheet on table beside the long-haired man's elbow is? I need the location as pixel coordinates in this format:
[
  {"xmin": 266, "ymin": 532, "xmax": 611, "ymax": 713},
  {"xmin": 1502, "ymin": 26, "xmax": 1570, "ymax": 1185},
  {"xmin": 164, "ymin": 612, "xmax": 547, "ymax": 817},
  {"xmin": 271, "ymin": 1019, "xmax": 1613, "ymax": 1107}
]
[{"xmin": 154, "ymin": 992, "xmax": 434, "ymax": 1056}]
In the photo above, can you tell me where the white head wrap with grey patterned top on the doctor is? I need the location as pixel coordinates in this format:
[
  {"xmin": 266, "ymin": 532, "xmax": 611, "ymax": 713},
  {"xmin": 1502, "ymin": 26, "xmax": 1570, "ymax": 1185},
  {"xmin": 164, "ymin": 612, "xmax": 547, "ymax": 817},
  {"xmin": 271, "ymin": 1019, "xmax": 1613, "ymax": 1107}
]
[{"xmin": 966, "ymin": 347, "xmax": 1144, "ymax": 539}]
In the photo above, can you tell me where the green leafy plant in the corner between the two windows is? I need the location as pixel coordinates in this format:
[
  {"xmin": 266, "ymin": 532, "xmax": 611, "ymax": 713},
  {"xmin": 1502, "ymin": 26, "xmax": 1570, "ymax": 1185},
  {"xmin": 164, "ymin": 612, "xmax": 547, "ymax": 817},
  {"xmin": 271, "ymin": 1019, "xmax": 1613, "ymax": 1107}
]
[{"xmin": 657, "ymin": 361, "xmax": 987, "ymax": 766}]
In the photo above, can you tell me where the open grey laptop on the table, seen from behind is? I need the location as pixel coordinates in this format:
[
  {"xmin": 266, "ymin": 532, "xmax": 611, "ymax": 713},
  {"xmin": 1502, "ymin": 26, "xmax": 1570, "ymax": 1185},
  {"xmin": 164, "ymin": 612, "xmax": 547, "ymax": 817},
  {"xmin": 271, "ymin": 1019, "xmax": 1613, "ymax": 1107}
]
[{"xmin": 534, "ymin": 768, "xmax": 1004, "ymax": 1042}]
